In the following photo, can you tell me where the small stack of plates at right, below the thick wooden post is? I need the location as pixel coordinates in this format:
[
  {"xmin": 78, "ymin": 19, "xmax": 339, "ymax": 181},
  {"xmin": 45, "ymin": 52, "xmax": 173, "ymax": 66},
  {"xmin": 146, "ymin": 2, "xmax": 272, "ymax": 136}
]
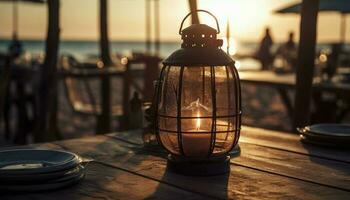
[{"xmin": 298, "ymin": 124, "xmax": 350, "ymax": 148}]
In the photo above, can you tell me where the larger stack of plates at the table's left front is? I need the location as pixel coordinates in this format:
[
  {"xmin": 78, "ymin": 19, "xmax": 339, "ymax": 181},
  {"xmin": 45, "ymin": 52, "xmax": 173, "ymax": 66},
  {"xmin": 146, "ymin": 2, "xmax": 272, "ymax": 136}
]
[{"xmin": 0, "ymin": 149, "xmax": 85, "ymax": 192}]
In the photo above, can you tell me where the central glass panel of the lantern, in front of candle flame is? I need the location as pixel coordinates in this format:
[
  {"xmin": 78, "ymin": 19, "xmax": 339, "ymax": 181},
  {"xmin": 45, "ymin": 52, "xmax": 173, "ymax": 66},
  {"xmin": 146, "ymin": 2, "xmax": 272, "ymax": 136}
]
[{"xmin": 180, "ymin": 66, "xmax": 213, "ymax": 157}]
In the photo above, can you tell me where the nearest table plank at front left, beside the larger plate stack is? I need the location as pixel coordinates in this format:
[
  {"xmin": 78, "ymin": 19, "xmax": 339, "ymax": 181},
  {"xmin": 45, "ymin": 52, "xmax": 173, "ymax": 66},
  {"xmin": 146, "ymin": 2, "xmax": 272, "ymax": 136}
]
[{"xmin": 0, "ymin": 163, "xmax": 208, "ymax": 200}]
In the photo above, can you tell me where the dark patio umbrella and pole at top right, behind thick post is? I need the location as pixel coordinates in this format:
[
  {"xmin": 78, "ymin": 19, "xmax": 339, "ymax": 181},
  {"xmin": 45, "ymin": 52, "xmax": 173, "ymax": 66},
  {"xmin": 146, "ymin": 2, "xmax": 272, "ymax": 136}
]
[{"xmin": 275, "ymin": 0, "xmax": 350, "ymax": 43}]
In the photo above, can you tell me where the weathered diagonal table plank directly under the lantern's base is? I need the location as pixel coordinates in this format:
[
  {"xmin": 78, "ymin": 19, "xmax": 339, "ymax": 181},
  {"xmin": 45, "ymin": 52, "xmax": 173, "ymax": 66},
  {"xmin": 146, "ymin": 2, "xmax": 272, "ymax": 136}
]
[{"xmin": 48, "ymin": 133, "xmax": 350, "ymax": 199}]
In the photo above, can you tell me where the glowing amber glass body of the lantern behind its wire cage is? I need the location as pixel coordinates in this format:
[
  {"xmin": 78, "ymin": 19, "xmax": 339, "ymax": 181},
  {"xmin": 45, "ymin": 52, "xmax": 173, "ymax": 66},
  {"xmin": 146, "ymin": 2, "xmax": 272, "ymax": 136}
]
[{"xmin": 158, "ymin": 66, "xmax": 240, "ymax": 157}]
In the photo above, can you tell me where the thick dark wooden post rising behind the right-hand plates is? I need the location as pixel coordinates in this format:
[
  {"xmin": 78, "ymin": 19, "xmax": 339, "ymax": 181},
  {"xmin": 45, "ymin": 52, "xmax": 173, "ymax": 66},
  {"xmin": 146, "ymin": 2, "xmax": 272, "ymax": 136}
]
[{"xmin": 293, "ymin": 0, "xmax": 319, "ymax": 130}]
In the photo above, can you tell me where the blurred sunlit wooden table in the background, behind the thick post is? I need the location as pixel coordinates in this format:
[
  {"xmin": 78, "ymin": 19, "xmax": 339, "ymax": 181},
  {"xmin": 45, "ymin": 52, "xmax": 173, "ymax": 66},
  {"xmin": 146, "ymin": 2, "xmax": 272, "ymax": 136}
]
[{"xmin": 239, "ymin": 71, "xmax": 350, "ymax": 122}]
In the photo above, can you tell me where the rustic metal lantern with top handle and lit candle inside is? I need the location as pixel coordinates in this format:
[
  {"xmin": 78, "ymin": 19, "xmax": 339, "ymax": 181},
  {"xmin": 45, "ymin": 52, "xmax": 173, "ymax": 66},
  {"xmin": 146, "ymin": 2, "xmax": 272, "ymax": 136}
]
[{"xmin": 156, "ymin": 10, "xmax": 241, "ymax": 175}]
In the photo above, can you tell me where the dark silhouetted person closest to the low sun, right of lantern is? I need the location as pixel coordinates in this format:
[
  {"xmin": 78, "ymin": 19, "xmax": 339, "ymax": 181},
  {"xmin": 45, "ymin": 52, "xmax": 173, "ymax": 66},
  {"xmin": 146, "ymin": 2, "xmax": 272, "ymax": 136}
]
[{"xmin": 257, "ymin": 28, "xmax": 273, "ymax": 70}]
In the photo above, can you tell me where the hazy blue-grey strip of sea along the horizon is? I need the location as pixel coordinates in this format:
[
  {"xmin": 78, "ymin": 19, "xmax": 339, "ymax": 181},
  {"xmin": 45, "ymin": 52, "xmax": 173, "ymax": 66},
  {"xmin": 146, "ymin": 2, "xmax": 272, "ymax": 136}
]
[{"xmin": 0, "ymin": 39, "xmax": 350, "ymax": 69}]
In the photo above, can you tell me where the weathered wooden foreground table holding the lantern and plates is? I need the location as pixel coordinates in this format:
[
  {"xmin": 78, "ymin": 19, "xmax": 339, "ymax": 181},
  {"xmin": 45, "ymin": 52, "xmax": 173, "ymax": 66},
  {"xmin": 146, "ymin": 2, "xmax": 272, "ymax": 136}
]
[{"xmin": 0, "ymin": 127, "xmax": 350, "ymax": 200}]
